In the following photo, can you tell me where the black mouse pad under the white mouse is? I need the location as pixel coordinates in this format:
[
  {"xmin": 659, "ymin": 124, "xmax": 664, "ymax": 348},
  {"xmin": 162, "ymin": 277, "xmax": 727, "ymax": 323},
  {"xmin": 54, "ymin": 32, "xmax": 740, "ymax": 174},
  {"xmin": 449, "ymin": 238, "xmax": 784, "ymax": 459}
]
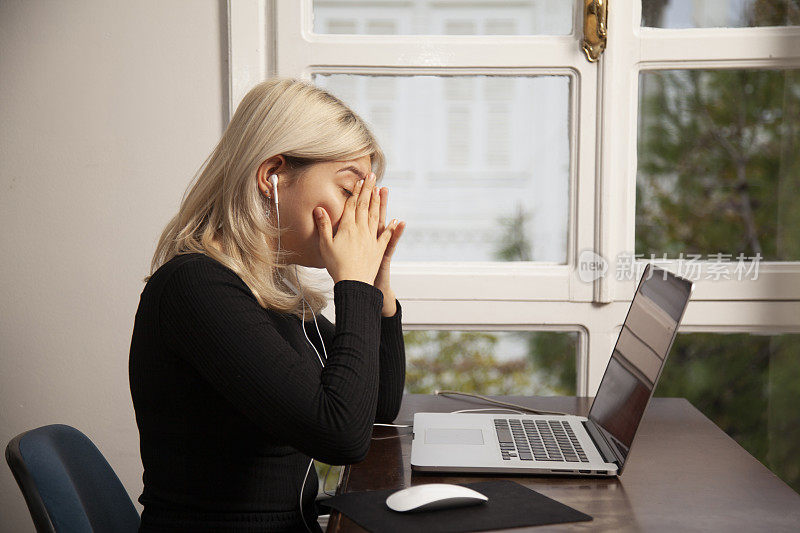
[{"xmin": 320, "ymin": 480, "xmax": 592, "ymax": 533}]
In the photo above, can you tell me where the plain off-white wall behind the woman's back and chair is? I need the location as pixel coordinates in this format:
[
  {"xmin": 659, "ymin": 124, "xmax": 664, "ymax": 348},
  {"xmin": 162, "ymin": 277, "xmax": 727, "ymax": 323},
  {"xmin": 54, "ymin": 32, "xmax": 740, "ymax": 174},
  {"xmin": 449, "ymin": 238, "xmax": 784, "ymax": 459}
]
[{"xmin": 0, "ymin": 0, "xmax": 227, "ymax": 532}]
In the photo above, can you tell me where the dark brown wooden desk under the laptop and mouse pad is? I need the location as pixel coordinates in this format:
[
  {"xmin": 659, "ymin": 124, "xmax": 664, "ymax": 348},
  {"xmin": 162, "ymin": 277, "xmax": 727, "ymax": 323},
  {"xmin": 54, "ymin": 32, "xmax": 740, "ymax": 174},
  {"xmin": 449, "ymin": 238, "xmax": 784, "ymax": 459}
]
[{"xmin": 327, "ymin": 395, "xmax": 800, "ymax": 532}]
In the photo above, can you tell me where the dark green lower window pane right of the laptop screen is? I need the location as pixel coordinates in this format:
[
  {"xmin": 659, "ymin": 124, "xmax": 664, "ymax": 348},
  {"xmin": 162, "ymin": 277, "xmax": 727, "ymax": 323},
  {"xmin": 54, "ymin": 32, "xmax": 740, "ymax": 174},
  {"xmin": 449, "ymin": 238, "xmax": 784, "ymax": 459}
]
[{"xmin": 655, "ymin": 333, "xmax": 800, "ymax": 492}]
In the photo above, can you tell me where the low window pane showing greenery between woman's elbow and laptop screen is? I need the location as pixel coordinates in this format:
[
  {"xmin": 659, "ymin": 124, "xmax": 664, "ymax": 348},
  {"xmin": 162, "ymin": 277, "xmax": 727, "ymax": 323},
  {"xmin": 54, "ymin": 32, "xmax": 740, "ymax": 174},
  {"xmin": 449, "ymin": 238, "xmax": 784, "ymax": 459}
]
[{"xmin": 403, "ymin": 330, "xmax": 579, "ymax": 396}]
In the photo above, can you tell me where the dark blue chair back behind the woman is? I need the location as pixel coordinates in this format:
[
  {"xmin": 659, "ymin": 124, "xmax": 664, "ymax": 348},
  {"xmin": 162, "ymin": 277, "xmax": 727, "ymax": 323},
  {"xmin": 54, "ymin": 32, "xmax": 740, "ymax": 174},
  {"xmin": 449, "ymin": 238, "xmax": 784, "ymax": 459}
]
[{"xmin": 6, "ymin": 424, "xmax": 139, "ymax": 533}]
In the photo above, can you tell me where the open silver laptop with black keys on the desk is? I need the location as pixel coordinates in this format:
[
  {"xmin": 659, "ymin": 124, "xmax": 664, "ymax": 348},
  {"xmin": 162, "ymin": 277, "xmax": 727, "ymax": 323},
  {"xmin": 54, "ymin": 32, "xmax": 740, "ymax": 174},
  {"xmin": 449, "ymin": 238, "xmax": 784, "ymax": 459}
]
[{"xmin": 411, "ymin": 264, "xmax": 692, "ymax": 476}]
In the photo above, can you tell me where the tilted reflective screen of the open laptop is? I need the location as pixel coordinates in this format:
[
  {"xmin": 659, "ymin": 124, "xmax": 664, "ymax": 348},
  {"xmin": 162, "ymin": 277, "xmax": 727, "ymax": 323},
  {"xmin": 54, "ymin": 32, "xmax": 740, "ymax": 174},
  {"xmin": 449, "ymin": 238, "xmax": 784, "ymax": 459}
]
[{"xmin": 588, "ymin": 265, "xmax": 692, "ymax": 467}]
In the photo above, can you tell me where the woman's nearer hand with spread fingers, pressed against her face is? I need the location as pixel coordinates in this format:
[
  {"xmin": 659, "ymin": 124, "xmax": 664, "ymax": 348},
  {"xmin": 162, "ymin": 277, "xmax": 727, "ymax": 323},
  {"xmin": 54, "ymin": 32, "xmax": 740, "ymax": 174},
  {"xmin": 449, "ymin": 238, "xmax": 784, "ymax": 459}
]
[{"xmin": 314, "ymin": 173, "xmax": 397, "ymax": 284}]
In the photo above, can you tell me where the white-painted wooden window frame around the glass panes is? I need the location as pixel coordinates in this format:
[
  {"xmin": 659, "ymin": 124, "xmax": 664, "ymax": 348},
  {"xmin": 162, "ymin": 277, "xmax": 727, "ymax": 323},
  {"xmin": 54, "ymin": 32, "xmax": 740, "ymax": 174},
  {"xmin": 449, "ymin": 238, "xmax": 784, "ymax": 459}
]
[{"xmin": 228, "ymin": 0, "xmax": 800, "ymax": 395}]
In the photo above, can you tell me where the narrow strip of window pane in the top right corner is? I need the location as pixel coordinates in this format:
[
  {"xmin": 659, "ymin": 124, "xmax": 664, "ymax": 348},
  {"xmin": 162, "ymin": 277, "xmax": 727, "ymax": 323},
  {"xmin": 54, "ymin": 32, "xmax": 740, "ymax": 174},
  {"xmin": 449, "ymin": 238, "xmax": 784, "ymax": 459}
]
[{"xmin": 642, "ymin": 0, "xmax": 800, "ymax": 29}]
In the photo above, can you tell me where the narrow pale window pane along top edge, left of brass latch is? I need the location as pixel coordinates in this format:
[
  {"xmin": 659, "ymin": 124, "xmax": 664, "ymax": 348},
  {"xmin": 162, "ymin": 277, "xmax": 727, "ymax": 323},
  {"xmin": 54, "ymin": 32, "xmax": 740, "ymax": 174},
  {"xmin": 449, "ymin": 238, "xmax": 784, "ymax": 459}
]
[{"xmin": 314, "ymin": 0, "xmax": 575, "ymax": 35}]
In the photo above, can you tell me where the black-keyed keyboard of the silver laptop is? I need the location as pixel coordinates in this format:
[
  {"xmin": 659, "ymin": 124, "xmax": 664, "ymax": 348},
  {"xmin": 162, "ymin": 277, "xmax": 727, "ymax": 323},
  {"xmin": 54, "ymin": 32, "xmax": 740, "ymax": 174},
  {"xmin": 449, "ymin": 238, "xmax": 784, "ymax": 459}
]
[{"xmin": 494, "ymin": 418, "xmax": 589, "ymax": 463}]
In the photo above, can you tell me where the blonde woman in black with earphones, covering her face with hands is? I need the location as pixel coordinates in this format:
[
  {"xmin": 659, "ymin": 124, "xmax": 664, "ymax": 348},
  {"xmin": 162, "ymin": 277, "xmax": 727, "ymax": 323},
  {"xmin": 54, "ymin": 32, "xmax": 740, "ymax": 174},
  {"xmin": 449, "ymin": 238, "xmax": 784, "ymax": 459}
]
[{"xmin": 129, "ymin": 79, "xmax": 405, "ymax": 532}]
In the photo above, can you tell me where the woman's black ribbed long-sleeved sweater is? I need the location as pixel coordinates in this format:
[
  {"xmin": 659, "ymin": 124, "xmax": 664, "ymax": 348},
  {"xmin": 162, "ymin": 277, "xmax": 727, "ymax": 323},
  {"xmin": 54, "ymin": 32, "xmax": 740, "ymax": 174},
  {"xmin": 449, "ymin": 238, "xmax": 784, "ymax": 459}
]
[{"xmin": 129, "ymin": 254, "xmax": 405, "ymax": 532}]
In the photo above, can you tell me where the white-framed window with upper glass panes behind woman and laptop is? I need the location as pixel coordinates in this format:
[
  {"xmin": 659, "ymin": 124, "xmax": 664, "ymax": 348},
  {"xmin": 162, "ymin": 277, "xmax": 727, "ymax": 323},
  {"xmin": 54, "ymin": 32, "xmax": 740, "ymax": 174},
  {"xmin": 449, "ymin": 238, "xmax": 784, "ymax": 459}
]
[{"xmin": 229, "ymin": 0, "xmax": 800, "ymax": 395}]
